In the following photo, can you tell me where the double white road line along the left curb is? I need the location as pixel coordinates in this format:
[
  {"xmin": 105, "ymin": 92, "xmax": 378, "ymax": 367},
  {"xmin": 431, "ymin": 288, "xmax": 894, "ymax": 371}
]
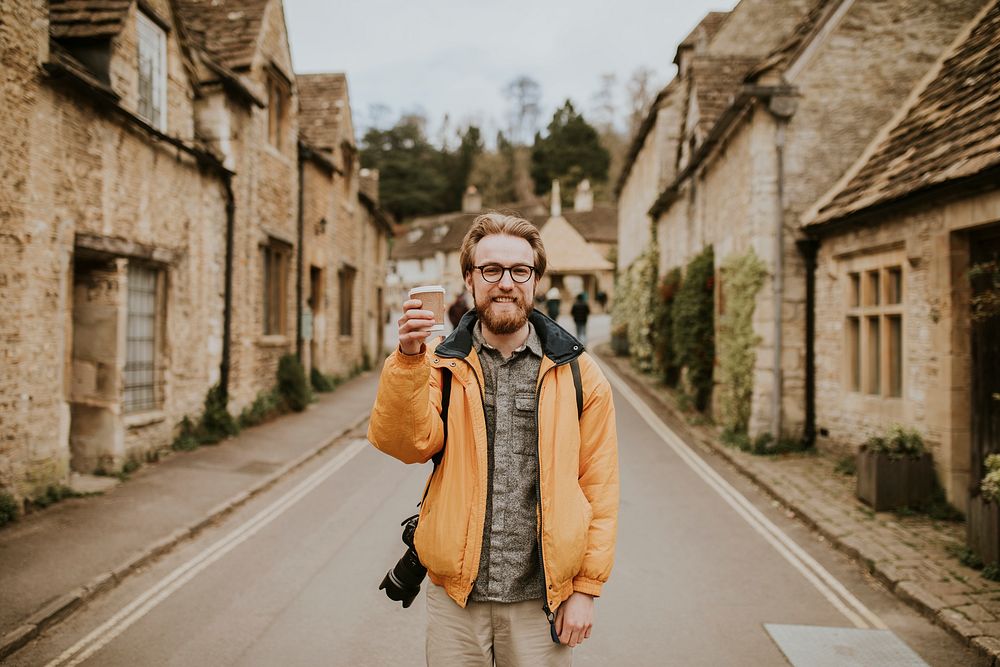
[{"xmin": 46, "ymin": 440, "xmax": 369, "ymax": 667}]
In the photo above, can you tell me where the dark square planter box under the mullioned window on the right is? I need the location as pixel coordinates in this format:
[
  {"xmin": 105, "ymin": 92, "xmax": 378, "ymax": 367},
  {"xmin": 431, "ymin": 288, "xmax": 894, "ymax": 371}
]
[{"xmin": 857, "ymin": 448, "xmax": 935, "ymax": 512}]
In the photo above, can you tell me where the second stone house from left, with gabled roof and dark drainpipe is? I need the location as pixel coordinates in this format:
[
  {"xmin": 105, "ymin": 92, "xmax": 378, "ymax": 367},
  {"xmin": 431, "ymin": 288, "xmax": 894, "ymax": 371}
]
[{"xmin": 176, "ymin": 0, "xmax": 299, "ymax": 413}]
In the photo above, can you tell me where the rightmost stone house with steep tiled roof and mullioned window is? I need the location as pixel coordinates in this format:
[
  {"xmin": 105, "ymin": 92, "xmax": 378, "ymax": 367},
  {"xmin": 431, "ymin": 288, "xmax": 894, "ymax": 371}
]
[{"xmin": 804, "ymin": 0, "xmax": 1000, "ymax": 510}]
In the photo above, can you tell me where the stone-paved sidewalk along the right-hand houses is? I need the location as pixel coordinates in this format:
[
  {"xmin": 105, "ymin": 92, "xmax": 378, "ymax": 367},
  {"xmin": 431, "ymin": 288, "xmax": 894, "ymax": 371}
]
[{"xmin": 597, "ymin": 345, "xmax": 1000, "ymax": 667}]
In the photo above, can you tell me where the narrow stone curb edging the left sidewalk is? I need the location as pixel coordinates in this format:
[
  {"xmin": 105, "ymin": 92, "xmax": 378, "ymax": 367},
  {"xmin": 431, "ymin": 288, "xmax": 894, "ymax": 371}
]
[{"xmin": 0, "ymin": 414, "xmax": 368, "ymax": 661}]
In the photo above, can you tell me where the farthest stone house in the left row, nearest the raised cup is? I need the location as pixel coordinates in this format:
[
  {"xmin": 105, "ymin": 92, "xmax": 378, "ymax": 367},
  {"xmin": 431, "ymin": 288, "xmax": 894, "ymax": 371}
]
[{"xmin": 297, "ymin": 73, "xmax": 391, "ymax": 375}]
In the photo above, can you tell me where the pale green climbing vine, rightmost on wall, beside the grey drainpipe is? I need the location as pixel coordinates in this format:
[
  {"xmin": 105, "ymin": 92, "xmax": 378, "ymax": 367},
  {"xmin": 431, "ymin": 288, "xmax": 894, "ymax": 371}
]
[{"xmin": 717, "ymin": 249, "xmax": 767, "ymax": 433}]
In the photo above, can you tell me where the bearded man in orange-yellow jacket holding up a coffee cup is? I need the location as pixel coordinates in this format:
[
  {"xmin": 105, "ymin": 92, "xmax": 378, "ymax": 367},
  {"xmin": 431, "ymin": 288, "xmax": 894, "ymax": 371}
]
[{"xmin": 368, "ymin": 213, "xmax": 618, "ymax": 667}]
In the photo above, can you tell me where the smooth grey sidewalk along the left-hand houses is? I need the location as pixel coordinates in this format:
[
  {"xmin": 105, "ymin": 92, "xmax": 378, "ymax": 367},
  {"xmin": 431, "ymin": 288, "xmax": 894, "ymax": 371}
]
[{"xmin": 0, "ymin": 372, "xmax": 378, "ymax": 660}]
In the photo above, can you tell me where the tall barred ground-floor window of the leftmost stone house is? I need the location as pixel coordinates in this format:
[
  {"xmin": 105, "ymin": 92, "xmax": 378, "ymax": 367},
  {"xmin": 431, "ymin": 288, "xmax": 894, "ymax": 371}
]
[{"xmin": 124, "ymin": 264, "xmax": 163, "ymax": 413}]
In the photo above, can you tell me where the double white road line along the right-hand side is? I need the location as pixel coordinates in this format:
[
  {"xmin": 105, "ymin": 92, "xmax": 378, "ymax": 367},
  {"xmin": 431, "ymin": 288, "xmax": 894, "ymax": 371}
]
[{"xmin": 601, "ymin": 363, "xmax": 888, "ymax": 630}]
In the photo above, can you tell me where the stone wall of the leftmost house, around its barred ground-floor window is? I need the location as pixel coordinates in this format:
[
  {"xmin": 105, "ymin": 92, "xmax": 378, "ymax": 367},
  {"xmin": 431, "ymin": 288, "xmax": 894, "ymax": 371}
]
[{"xmin": 0, "ymin": 3, "xmax": 226, "ymax": 497}]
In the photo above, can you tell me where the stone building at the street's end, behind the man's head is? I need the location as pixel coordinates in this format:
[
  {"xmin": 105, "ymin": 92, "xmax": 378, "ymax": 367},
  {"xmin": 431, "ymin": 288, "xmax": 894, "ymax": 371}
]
[{"xmin": 386, "ymin": 181, "xmax": 618, "ymax": 320}]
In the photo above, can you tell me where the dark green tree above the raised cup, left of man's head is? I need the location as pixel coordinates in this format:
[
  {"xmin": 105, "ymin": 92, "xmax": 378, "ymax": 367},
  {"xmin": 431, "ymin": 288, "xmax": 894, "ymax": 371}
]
[{"xmin": 361, "ymin": 114, "xmax": 450, "ymax": 219}]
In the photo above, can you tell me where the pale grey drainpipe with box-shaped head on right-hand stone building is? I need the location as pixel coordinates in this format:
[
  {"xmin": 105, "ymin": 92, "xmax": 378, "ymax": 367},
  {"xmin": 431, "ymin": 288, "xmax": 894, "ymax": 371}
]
[{"xmin": 767, "ymin": 95, "xmax": 797, "ymax": 442}]
